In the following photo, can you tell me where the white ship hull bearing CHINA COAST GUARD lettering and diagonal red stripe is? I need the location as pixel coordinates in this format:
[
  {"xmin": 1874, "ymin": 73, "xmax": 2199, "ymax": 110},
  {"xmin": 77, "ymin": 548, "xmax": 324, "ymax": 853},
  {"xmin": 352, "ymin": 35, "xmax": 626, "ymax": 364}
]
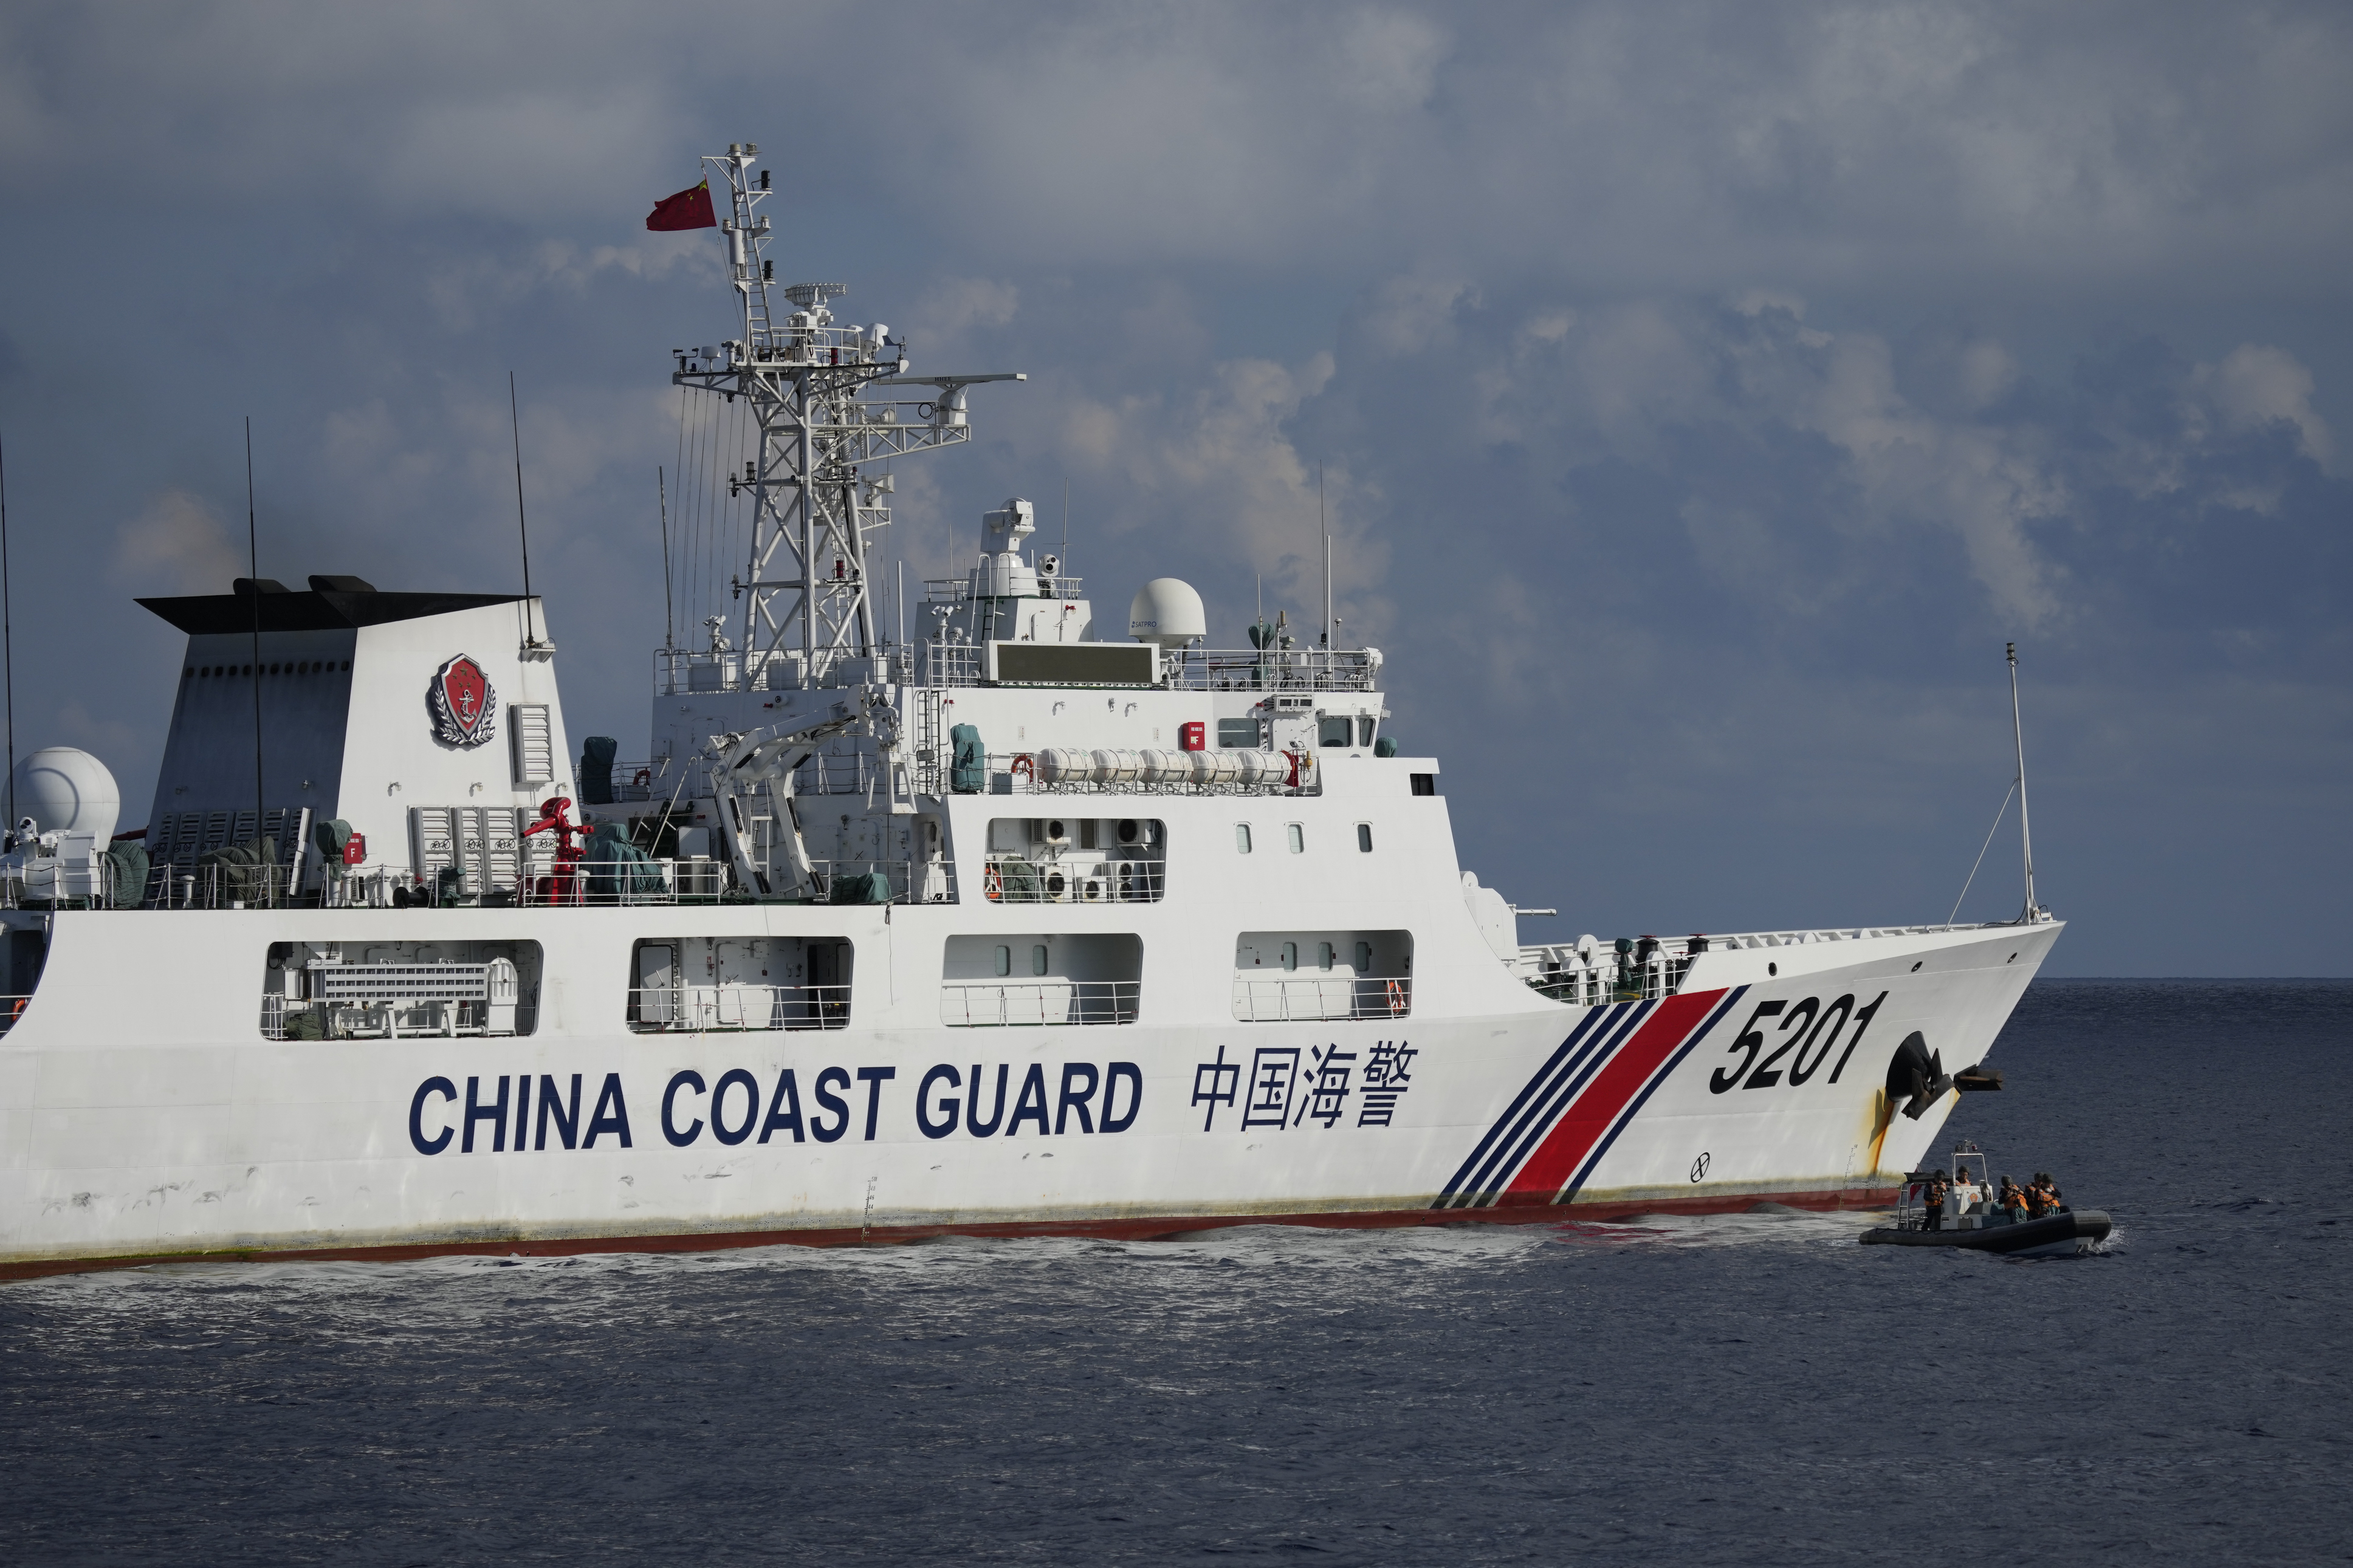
[{"xmin": 0, "ymin": 908, "xmax": 2061, "ymax": 1274}]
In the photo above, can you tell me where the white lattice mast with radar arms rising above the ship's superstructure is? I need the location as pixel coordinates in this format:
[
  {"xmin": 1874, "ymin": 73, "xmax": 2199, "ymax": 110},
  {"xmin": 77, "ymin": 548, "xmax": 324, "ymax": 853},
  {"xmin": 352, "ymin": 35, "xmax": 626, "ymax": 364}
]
[{"xmin": 671, "ymin": 141, "xmax": 1026, "ymax": 689}]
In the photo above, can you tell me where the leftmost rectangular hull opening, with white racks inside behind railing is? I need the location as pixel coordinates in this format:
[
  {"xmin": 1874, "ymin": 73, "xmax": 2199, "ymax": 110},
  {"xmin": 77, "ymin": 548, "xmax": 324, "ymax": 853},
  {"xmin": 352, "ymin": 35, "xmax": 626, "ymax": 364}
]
[{"xmin": 261, "ymin": 938, "xmax": 541, "ymax": 1041}]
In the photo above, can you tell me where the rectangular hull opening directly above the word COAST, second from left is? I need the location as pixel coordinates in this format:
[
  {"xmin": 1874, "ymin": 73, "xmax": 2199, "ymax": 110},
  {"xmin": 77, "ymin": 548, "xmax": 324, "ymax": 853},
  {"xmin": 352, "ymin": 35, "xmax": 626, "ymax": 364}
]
[{"xmin": 628, "ymin": 936, "xmax": 854, "ymax": 1035}]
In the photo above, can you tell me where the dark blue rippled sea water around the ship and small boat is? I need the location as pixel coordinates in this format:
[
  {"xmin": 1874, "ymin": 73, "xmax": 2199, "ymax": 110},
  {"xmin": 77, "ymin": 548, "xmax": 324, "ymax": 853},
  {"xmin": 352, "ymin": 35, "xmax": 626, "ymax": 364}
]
[{"xmin": 0, "ymin": 981, "xmax": 2353, "ymax": 1563}]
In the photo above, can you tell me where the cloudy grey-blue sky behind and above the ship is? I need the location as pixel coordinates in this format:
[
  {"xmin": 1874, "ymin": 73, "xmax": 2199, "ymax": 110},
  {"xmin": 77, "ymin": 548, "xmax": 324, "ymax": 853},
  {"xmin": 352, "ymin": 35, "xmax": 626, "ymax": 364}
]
[{"xmin": 0, "ymin": 0, "xmax": 2353, "ymax": 976}]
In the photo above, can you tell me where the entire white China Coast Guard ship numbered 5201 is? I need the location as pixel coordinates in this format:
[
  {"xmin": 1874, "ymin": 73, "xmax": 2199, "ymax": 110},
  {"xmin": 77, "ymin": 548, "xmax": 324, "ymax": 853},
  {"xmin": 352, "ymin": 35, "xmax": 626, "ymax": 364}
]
[{"xmin": 0, "ymin": 146, "xmax": 2059, "ymax": 1274}]
